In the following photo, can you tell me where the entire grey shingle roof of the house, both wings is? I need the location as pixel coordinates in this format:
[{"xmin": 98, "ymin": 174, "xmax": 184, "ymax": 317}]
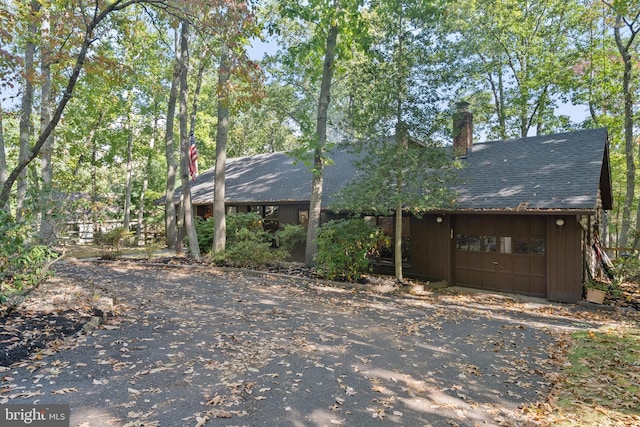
[{"xmin": 177, "ymin": 129, "xmax": 609, "ymax": 210}]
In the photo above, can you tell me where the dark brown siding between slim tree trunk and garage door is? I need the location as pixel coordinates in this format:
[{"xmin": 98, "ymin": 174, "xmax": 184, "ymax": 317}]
[{"xmin": 407, "ymin": 215, "xmax": 451, "ymax": 280}]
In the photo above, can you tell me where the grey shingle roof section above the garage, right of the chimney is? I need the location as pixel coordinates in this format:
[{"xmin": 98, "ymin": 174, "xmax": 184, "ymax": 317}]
[{"xmin": 455, "ymin": 129, "xmax": 607, "ymax": 209}]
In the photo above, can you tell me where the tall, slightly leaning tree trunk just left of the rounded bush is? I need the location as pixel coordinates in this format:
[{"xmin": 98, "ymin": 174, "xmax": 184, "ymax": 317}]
[{"xmin": 305, "ymin": 25, "xmax": 338, "ymax": 266}]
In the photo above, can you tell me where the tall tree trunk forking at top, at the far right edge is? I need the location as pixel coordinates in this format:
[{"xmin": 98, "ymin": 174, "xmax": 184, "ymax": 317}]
[{"xmin": 614, "ymin": 15, "xmax": 640, "ymax": 247}]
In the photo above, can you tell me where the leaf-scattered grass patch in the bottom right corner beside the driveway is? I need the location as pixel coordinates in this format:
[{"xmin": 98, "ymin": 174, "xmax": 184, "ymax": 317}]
[{"xmin": 552, "ymin": 326, "xmax": 640, "ymax": 426}]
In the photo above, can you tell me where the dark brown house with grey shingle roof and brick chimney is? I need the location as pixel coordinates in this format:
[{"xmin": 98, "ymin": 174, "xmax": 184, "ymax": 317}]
[{"xmin": 172, "ymin": 114, "xmax": 613, "ymax": 302}]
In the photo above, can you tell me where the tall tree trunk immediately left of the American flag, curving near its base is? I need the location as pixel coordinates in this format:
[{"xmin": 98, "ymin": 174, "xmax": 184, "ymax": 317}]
[{"xmin": 178, "ymin": 21, "xmax": 200, "ymax": 261}]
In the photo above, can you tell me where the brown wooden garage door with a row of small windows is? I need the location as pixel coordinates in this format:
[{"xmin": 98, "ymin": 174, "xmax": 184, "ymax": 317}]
[{"xmin": 454, "ymin": 215, "xmax": 546, "ymax": 297}]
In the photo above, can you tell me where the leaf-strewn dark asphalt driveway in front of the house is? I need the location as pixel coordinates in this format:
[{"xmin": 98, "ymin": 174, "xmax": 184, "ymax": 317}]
[{"xmin": 2, "ymin": 263, "xmax": 604, "ymax": 427}]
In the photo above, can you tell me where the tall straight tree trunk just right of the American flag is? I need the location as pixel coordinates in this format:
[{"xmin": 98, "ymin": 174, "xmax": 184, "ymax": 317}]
[{"xmin": 213, "ymin": 44, "xmax": 231, "ymax": 253}]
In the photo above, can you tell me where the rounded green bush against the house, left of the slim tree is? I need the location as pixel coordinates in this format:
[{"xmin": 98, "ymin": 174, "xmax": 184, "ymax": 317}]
[{"xmin": 316, "ymin": 218, "xmax": 389, "ymax": 281}]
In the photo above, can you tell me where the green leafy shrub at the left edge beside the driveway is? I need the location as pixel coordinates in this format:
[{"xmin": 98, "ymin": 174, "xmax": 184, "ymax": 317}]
[{"xmin": 0, "ymin": 210, "xmax": 57, "ymax": 302}]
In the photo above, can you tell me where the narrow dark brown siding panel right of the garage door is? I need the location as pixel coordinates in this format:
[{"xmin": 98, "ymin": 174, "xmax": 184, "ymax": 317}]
[{"xmin": 547, "ymin": 216, "xmax": 583, "ymax": 303}]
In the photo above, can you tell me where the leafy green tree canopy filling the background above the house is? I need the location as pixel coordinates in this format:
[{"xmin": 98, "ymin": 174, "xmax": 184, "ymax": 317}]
[{"xmin": 0, "ymin": 0, "xmax": 640, "ymax": 254}]
